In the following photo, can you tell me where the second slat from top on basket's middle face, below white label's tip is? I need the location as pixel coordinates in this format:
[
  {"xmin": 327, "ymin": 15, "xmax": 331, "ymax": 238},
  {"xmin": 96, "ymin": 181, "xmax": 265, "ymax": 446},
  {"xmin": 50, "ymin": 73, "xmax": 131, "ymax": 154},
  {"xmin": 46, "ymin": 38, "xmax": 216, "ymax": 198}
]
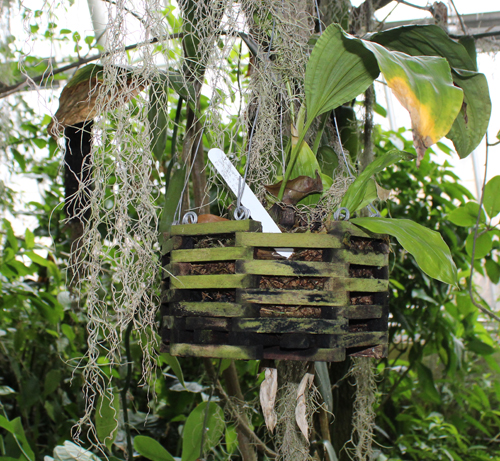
[{"xmin": 236, "ymin": 260, "xmax": 348, "ymax": 277}]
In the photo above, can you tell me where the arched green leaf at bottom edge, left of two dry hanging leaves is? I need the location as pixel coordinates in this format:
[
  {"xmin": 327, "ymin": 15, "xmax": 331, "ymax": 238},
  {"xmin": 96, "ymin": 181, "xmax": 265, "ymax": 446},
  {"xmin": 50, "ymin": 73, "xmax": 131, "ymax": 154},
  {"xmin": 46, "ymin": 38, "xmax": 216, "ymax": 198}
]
[{"xmin": 182, "ymin": 402, "xmax": 225, "ymax": 461}]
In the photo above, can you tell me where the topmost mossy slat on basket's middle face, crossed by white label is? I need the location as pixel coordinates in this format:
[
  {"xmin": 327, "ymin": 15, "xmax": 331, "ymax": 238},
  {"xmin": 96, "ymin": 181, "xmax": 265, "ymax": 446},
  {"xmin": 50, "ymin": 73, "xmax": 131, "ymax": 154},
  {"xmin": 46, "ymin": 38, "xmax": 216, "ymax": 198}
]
[{"xmin": 236, "ymin": 232, "xmax": 342, "ymax": 248}]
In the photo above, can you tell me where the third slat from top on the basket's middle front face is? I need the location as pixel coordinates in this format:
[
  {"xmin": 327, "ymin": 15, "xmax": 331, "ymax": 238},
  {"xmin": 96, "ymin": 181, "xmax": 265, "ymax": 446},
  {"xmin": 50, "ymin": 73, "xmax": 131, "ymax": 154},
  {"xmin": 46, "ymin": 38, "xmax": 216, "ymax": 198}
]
[{"xmin": 236, "ymin": 288, "xmax": 348, "ymax": 306}]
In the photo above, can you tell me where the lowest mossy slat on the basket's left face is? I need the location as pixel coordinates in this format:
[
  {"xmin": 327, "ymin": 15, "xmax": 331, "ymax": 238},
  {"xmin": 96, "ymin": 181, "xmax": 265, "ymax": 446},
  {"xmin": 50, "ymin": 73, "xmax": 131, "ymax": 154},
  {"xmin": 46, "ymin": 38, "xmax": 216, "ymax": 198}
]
[{"xmin": 170, "ymin": 343, "xmax": 262, "ymax": 360}]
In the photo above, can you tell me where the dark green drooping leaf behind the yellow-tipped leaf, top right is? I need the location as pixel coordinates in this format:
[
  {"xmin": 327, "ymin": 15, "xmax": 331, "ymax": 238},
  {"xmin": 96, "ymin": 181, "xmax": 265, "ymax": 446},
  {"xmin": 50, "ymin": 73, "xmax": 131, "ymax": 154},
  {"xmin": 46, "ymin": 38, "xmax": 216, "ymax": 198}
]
[{"xmin": 371, "ymin": 25, "xmax": 491, "ymax": 158}]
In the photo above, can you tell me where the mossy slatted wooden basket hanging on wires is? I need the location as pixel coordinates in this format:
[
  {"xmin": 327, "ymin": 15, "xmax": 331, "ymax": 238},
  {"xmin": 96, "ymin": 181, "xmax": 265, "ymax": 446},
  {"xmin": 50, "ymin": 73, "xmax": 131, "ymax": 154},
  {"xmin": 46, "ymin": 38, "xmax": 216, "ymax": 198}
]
[{"xmin": 161, "ymin": 220, "xmax": 389, "ymax": 362}]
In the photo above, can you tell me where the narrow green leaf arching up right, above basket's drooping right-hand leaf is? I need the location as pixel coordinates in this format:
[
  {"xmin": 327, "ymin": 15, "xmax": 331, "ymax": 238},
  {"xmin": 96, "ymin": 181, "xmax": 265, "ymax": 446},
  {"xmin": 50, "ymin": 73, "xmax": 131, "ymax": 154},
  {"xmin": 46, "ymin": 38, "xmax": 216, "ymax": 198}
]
[{"xmin": 340, "ymin": 150, "xmax": 415, "ymax": 213}]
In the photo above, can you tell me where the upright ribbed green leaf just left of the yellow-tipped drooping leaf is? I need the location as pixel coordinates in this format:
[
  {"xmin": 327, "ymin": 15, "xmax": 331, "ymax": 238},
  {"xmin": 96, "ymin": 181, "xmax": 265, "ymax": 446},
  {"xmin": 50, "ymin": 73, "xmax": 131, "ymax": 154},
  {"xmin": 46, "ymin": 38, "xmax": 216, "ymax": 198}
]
[{"xmin": 305, "ymin": 24, "xmax": 379, "ymax": 119}]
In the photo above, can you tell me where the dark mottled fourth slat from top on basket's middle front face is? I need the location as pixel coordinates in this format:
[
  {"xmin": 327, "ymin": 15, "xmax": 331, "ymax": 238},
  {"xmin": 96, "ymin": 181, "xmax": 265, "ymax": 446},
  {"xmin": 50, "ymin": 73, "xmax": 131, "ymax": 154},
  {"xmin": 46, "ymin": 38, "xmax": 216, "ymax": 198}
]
[{"xmin": 232, "ymin": 318, "xmax": 347, "ymax": 334}]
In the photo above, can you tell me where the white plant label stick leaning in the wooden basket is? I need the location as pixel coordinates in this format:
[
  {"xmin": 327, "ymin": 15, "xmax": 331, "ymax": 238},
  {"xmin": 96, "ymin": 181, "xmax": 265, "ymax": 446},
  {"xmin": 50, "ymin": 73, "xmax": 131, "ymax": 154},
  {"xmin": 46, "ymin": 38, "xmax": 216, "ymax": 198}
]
[{"xmin": 208, "ymin": 149, "xmax": 293, "ymax": 258}]
